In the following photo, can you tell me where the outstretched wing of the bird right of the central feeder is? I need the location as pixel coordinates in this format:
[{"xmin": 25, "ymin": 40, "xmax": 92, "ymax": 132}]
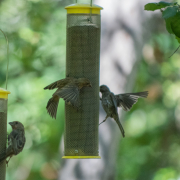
[{"xmin": 115, "ymin": 91, "xmax": 148, "ymax": 111}]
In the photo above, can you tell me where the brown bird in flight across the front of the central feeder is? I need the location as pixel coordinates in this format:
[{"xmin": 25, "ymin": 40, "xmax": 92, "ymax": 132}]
[{"xmin": 44, "ymin": 77, "xmax": 92, "ymax": 119}]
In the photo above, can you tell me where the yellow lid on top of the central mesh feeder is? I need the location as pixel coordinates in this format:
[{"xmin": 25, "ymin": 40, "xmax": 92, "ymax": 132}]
[{"xmin": 65, "ymin": 3, "xmax": 103, "ymax": 14}]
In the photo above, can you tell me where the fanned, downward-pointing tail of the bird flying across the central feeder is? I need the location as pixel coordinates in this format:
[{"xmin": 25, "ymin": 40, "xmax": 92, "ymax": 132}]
[{"xmin": 46, "ymin": 96, "xmax": 59, "ymax": 119}]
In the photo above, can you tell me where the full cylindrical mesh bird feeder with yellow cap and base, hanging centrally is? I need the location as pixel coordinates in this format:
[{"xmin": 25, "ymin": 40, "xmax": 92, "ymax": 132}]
[{"xmin": 63, "ymin": 4, "xmax": 102, "ymax": 158}]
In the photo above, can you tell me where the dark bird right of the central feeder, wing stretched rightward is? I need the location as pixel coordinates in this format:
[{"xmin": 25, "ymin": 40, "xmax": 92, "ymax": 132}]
[{"xmin": 99, "ymin": 85, "xmax": 148, "ymax": 137}]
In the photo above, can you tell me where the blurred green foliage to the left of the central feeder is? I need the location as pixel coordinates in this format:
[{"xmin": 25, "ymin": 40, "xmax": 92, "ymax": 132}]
[{"xmin": 0, "ymin": 0, "xmax": 66, "ymax": 180}]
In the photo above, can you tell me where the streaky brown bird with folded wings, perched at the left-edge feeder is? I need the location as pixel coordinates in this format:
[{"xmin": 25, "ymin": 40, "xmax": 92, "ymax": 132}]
[{"xmin": 0, "ymin": 121, "xmax": 26, "ymax": 164}]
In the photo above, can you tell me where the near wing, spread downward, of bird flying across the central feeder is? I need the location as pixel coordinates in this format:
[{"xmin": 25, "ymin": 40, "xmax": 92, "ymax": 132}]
[{"xmin": 53, "ymin": 83, "xmax": 79, "ymax": 108}]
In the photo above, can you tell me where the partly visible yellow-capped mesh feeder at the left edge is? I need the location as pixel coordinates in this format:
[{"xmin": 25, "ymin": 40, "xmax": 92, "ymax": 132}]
[{"xmin": 0, "ymin": 88, "xmax": 10, "ymax": 180}]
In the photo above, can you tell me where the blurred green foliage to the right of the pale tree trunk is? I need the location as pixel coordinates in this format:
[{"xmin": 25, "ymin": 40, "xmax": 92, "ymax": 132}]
[{"xmin": 116, "ymin": 13, "xmax": 180, "ymax": 180}]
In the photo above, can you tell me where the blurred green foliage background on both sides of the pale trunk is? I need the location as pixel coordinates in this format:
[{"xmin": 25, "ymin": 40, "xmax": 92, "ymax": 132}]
[{"xmin": 0, "ymin": 0, "xmax": 180, "ymax": 180}]
